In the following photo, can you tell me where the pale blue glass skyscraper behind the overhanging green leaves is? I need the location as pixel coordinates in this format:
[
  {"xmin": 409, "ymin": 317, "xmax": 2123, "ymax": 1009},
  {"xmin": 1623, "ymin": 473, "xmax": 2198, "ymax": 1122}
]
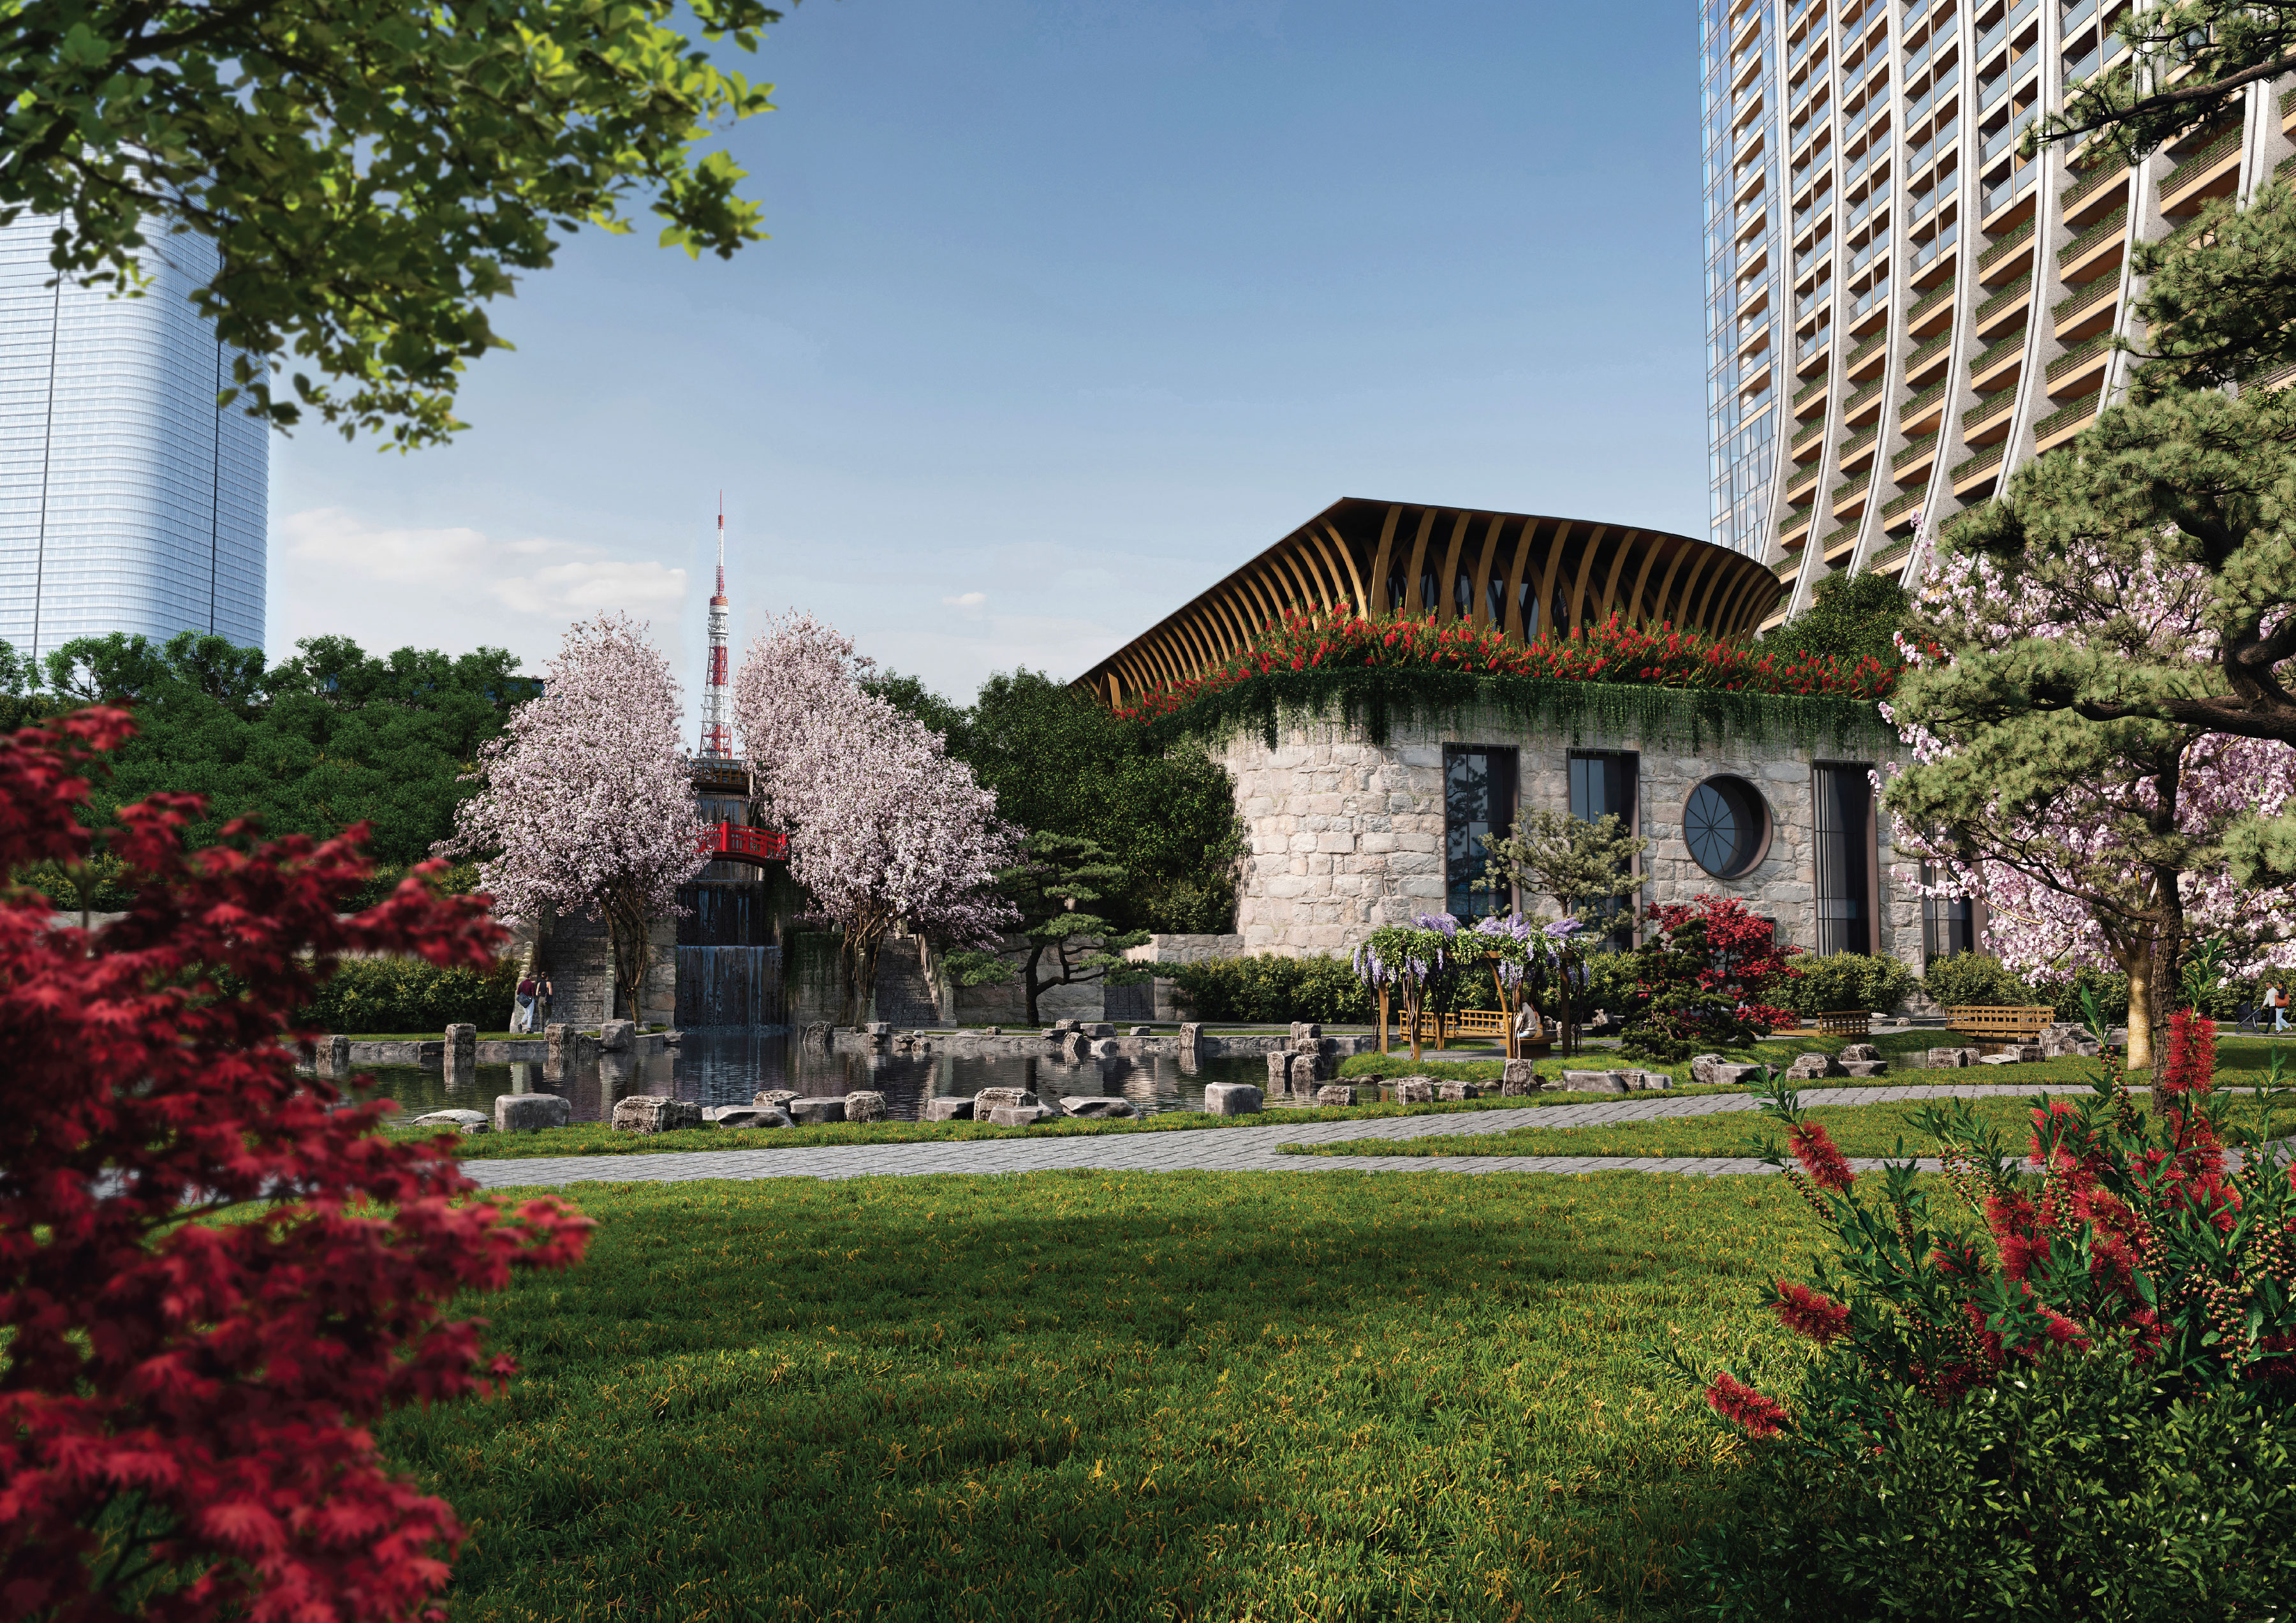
[{"xmin": 0, "ymin": 218, "xmax": 269, "ymax": 655}]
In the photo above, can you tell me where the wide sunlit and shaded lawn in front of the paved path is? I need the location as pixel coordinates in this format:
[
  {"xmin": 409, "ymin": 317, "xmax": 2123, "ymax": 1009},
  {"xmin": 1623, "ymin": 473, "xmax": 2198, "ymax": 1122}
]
[{"xmin": 395, "ymin": 1171, "xmax": 1821, "ymax": 1623}]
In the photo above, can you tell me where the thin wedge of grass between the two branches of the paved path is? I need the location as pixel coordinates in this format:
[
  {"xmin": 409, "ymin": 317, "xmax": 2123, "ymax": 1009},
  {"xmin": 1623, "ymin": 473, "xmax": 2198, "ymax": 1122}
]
[{"xmin": 1281, "ymin": 1095, "xmax": 2158, "ymax": 1157}]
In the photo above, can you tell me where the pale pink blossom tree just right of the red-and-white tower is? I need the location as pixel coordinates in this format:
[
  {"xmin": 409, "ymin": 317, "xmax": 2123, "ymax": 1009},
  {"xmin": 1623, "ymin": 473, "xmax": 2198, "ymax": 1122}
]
[{"xmin": 732, "ymin": 615, "xmax": 1019, "ymax": 1024}]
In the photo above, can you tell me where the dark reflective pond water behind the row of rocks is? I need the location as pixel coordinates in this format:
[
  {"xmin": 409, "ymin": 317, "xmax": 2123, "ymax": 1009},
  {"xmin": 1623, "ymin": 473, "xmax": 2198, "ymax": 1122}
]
[{"xmin": 346, "ymin": 1026, "xmax": 1267, "ymax": 1123}]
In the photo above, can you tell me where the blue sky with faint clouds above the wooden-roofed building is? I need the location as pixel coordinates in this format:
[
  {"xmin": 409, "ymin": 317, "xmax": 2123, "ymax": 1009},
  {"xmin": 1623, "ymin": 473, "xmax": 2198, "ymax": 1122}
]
[{"xmin": 269, "ymin": 0, "xmax": 1706, "ymax": 698}]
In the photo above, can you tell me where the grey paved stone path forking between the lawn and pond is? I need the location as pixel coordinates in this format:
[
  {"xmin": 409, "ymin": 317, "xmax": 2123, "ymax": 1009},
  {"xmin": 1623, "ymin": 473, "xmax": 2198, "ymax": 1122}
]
[{"xmin": 462, "ymin": 1083, "xmax": 2087, "ymax": 1189}]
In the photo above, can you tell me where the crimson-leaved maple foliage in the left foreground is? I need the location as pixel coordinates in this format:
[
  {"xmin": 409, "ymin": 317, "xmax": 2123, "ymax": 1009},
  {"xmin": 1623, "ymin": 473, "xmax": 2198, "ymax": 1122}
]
[{"xmin": 0, "ymin": 709, "xmax": 590, "ymax": 1623}]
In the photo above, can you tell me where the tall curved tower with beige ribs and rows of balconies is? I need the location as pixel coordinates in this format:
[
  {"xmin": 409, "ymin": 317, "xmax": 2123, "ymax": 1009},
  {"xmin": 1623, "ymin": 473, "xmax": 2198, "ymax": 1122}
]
[{"xmin": 1699, "ymin": 0, "xmax": 2296, "ymax": 625}]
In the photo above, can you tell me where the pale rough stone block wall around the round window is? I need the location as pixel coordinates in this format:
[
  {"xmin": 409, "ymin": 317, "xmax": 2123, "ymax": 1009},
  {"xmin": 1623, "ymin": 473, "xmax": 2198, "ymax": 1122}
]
[{"xmin": 1221, "ymin": 721, "xmax": 1922, "ymax": 971}]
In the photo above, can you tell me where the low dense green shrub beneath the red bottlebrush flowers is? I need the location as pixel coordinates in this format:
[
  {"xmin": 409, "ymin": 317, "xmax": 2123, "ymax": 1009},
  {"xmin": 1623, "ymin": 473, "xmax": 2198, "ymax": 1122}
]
[{"xmin": 1685, "ymin": 1352, "xmax": 2296, "ymax": 1623}]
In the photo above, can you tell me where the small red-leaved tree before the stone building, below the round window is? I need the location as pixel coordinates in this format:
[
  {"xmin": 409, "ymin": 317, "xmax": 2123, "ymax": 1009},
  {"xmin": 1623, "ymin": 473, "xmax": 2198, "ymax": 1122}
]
[{"xmin": 1619, "ymin": 895, "xmax": 1802, "ymax": 1060}]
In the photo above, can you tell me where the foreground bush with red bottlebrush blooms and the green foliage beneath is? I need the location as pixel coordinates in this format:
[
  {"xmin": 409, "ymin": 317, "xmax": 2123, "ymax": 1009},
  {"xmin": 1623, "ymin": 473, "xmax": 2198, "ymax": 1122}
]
[{"xmin": 1676, "ymin": 1010, "xmax": 2296, "ymax": 1623}]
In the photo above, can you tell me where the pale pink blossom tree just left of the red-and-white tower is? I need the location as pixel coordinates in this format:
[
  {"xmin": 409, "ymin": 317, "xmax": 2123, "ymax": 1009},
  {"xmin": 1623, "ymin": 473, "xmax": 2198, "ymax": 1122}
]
[{"xmin": 436, "ymin": 615, "xmax": 705, "ymax": 1019}]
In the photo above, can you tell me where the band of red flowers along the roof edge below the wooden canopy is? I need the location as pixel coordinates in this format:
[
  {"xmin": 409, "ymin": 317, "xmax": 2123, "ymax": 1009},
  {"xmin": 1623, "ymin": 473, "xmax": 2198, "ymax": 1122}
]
[{"xmin": 1116, "ymin": 604, "xmax": 1903, "ymax": 721}]
